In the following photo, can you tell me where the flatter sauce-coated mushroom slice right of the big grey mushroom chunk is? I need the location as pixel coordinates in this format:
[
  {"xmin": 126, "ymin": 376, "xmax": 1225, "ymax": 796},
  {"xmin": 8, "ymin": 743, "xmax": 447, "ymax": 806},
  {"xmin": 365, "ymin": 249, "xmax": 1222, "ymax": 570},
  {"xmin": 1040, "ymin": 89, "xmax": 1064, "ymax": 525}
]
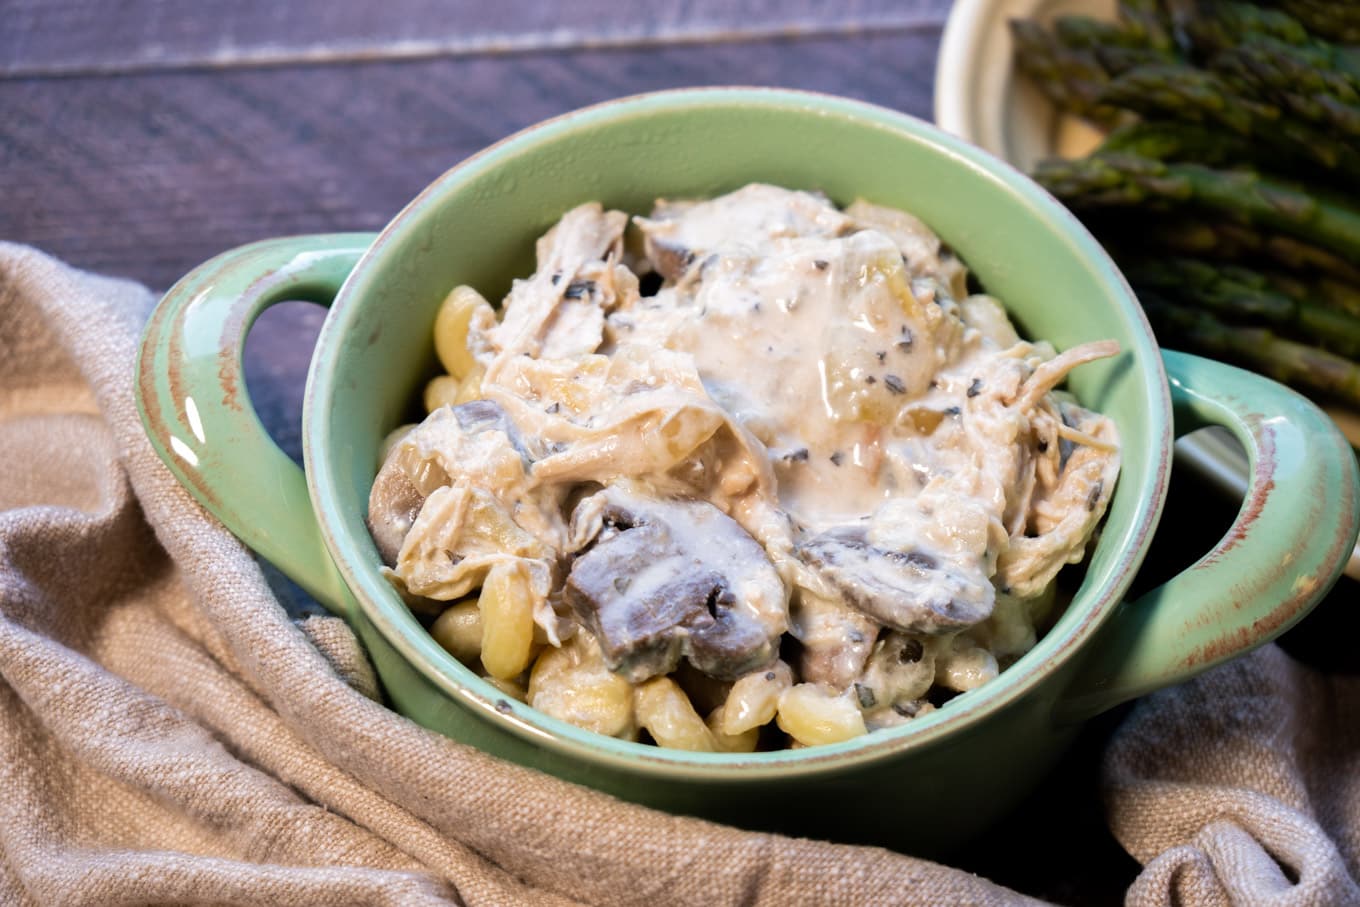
[{"xmin": 798, "ymin": 526, "xmax": 996, "ymax": 635}]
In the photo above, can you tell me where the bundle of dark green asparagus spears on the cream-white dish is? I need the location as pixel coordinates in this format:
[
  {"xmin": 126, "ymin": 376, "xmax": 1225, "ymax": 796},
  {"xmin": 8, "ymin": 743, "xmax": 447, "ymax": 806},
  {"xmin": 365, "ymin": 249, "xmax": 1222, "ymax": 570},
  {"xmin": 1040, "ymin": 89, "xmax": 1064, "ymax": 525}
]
[{"xmin": 1012, "ymin": 0, "xmax": 1360, "ymax": 407}]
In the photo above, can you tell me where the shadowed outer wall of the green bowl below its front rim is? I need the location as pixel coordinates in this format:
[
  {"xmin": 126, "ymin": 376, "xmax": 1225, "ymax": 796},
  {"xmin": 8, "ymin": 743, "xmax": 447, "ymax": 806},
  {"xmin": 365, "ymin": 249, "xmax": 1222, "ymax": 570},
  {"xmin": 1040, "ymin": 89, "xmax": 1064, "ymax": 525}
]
[{"xmin": 351, "ymin": 595, "xmax": 1078, "ymax": 857}]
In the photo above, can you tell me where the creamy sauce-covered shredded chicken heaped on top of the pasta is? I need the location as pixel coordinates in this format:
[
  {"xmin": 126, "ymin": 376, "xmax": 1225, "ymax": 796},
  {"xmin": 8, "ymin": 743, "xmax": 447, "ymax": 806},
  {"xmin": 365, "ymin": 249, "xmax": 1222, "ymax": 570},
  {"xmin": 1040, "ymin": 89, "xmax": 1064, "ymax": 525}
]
[{"xmin": 371, "ymin": 184, "xmax": 1119, "ymax": 725}]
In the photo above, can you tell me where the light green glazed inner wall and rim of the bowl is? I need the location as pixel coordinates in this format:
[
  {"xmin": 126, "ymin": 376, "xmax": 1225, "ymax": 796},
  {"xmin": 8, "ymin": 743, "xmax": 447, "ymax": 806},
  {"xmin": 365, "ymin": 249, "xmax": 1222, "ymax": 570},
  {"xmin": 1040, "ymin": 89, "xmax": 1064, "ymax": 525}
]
[{"xmin": 305, "ymin": 90, "xmax": 1171, "ymax": 771}]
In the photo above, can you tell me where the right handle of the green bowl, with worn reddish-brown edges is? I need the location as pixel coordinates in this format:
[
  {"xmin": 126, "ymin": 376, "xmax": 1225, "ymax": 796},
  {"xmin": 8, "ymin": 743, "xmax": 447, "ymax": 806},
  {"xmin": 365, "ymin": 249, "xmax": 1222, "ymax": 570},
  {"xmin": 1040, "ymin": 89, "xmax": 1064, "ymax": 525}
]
[{"xmin": 1057, "ymin": 351, "xmax": 1360, "ymax": 722}]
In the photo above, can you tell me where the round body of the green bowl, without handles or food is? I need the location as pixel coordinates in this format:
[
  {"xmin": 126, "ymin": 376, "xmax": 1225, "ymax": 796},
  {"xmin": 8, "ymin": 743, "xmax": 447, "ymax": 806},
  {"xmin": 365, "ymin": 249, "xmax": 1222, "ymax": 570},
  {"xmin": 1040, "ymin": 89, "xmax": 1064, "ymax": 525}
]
[{"xmin": 303, "ymin": 88, "xmax": 1172, "ymax": 853}]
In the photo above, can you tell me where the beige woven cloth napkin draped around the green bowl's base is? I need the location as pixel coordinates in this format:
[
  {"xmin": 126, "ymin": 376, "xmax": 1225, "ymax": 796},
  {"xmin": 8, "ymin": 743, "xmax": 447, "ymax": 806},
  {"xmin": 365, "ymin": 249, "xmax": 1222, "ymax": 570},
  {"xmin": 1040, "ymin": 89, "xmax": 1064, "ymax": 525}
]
[{"xmin": 0, "ymin": 245, "xmax": 1360, "ymax": 907}]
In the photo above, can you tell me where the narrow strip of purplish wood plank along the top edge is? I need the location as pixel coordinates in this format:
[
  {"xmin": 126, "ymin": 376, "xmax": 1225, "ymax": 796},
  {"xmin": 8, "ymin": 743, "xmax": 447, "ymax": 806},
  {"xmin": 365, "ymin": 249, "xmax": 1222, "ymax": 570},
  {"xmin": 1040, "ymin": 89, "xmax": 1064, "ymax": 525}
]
[{"xmin": 0, "ymin": 0, "xmax": 949, "ymax": 76}]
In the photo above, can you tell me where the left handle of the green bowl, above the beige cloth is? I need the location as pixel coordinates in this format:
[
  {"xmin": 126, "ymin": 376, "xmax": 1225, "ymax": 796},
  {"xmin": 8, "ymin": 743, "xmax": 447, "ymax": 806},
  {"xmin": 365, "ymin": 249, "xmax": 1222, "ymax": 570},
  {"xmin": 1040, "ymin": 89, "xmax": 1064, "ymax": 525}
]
[{"xmin": 136, "ymin": 234, "xmax": 374, "ymax": 616}]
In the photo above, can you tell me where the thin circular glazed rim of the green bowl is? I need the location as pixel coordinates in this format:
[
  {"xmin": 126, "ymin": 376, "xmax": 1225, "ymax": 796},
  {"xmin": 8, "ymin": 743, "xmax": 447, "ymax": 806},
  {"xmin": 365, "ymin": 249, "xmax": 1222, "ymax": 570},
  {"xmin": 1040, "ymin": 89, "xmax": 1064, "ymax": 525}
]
[{"xmin": 302, "ymin": 86, "xmax": 1171, "ymax": 782}]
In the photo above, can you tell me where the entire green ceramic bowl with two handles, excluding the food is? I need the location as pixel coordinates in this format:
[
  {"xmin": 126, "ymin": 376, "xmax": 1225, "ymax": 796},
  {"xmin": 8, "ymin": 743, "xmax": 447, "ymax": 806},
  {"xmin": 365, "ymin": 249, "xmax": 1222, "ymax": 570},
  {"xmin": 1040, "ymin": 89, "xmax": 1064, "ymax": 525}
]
[{"xmin": 139, "ymin": 88, "xmax": 1357, "ymax": 853}]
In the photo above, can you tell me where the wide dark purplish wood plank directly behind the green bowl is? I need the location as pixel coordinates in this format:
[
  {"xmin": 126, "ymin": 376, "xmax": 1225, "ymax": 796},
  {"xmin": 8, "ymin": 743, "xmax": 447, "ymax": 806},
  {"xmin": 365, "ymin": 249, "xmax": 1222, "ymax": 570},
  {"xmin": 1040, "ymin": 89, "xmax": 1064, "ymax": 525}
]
[{"xmin": 0, "ymin": 29, "xmax": 938, "ymax": 288}]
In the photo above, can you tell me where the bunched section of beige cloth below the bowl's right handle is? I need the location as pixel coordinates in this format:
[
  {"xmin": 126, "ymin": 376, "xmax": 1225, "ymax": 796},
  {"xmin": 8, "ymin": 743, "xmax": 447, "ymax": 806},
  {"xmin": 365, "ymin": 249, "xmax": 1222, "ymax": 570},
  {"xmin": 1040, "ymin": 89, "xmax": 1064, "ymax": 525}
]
[{"xmin": 1103, "ymin": 646, "xmax": 1360, "ymax": 907}]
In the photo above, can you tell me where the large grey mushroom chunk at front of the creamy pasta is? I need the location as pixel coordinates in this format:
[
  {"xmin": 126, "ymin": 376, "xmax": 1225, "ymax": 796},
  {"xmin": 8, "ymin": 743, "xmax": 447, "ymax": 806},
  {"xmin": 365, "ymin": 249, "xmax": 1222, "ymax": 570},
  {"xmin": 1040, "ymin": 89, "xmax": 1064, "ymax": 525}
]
[{"xmin": 564, "ymin": 487, "xmax": 787, "ymax": 683}]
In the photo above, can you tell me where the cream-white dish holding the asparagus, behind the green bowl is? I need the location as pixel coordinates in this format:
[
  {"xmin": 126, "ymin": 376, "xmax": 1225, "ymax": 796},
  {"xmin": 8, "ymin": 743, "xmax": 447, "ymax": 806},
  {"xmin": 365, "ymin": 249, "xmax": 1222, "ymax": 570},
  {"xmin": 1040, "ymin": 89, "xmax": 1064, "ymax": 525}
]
[{"xmin": 934, "ymin": 0, "xmax": 1360, "ymax": 579}]
